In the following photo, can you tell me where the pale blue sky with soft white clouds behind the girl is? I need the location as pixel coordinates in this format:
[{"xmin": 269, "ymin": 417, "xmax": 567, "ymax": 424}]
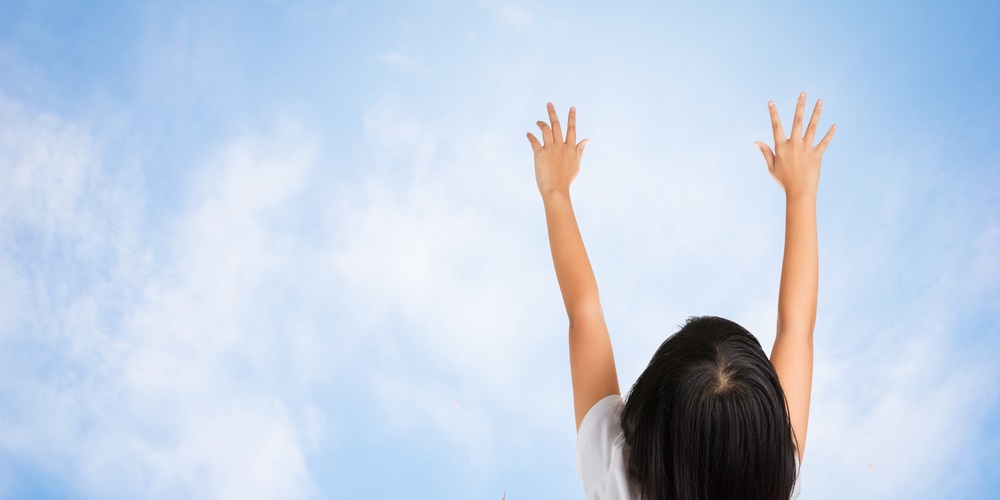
[{"xmin": 0, "ymin": 0, "xmax": 1000, "ymax": 499}]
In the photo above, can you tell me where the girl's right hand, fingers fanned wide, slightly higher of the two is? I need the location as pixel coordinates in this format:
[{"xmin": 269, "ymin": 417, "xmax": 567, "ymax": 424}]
[{"xmin": 754, "ymin": 92, "xmax": 837, "ymax": 197}]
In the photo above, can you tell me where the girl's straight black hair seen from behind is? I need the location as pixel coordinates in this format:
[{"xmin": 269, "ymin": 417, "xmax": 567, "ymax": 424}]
[{"xmin": 621, "ymin": 316, "xmax": 796, "ymax": 500}]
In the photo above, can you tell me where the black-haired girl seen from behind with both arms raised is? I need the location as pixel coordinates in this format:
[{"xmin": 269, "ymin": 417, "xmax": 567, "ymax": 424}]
[{"xmin": 528, "ymin": 92, "xmax": 836, "ymax": 500}]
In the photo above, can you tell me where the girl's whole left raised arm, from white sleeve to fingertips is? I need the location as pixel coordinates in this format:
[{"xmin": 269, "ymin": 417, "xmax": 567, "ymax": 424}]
[{"xmin": 528, "ymin": 103, "xmax": 621, "ymax": 430}]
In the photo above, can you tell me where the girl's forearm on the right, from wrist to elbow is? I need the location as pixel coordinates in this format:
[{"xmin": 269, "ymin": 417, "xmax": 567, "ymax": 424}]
[{"xmin": 778, "ymin": 194, "xmax": 819, "ymax": 338}]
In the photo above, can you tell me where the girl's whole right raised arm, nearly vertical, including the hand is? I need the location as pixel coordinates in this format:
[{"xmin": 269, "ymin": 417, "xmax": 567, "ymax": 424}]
[{"xmin": 755, "ymin": 92, "xmax": 837, "ymax": 461}]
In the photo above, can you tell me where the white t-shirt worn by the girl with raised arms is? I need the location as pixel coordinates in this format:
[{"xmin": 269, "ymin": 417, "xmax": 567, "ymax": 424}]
[{"xmin": 576, "ymin": 394, "xmax": 799, "ymax": 500}]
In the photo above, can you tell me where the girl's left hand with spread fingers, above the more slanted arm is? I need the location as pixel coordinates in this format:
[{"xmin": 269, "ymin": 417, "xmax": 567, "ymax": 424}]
[{"xmin": 528, "ymin": 102, "xmax": 590, "ymax": 194}]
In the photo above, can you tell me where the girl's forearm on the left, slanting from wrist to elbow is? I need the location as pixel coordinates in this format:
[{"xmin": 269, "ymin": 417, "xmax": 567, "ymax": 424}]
[{"xmin": 542, "ymin": 191, "xmax": 600, "ymax": 323}]
